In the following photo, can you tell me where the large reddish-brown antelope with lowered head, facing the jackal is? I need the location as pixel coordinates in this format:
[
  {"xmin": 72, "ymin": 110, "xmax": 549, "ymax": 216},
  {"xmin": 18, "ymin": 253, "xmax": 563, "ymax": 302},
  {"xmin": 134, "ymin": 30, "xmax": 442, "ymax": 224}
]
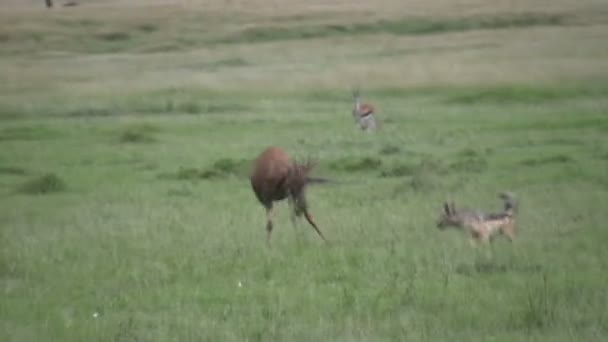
[{"xmin": 250, "ymin": 146, "xmax": 327, "ymax": 243}]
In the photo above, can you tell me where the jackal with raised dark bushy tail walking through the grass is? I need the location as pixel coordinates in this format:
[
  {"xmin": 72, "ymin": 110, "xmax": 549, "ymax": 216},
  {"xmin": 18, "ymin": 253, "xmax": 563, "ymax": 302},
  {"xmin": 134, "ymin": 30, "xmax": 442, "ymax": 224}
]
[{"xmin": 437, "ymin": 192, "xmax": 517, "ymax": 244}]
